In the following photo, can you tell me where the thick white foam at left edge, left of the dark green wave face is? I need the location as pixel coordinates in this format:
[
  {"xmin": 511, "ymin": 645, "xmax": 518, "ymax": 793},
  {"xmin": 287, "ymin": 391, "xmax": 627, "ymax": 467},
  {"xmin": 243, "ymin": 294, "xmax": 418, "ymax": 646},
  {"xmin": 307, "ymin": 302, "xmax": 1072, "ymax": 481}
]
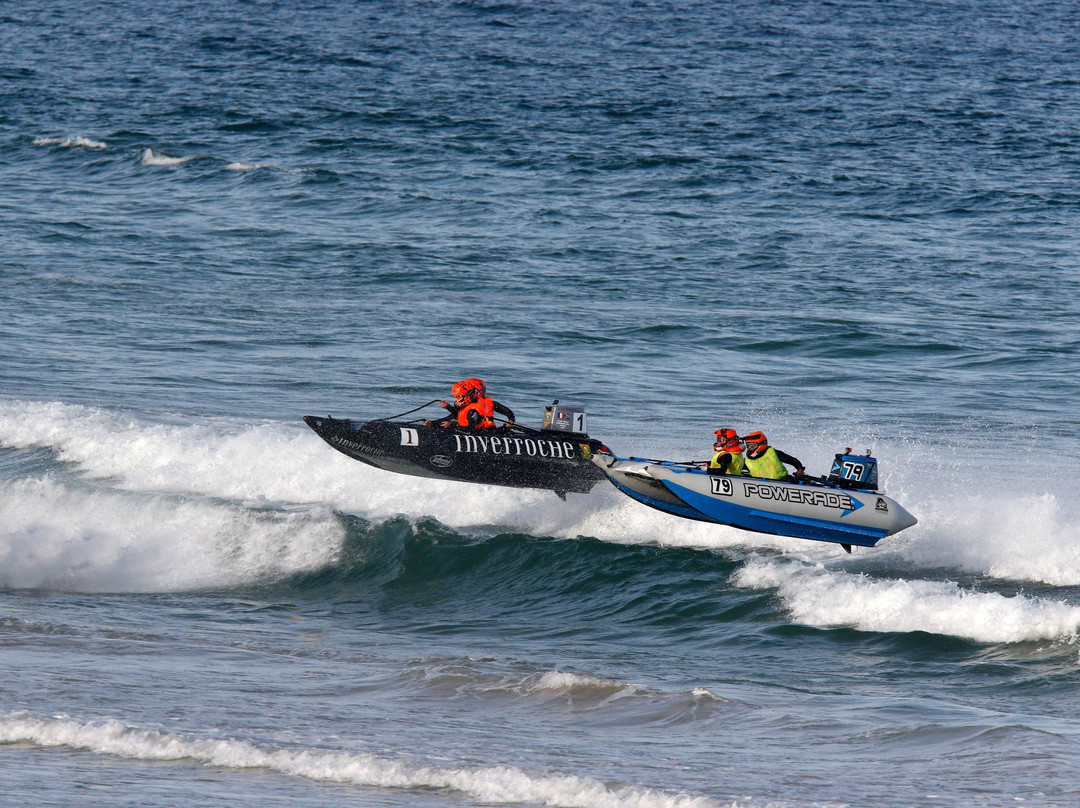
[{"xmin": 0, "ymin": 479, "xmax": 345, "ymax": 592}]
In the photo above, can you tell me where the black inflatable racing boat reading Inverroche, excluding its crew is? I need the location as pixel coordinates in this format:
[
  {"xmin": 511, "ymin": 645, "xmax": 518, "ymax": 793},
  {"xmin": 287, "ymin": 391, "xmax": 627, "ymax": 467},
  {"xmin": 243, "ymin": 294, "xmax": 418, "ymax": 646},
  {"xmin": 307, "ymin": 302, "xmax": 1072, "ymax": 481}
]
[{"xmin": 303, "ymin": 400, "xmax": 607, "ymax": 499}]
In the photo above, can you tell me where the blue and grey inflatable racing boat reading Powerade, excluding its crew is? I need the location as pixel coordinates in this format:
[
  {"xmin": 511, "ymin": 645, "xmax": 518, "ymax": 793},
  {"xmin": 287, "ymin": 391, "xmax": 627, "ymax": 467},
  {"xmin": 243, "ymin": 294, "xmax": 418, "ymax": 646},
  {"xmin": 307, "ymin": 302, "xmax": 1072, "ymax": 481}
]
[{"xmin": 593, "ymin": 449, "xmax": 918, "ymax": 552}]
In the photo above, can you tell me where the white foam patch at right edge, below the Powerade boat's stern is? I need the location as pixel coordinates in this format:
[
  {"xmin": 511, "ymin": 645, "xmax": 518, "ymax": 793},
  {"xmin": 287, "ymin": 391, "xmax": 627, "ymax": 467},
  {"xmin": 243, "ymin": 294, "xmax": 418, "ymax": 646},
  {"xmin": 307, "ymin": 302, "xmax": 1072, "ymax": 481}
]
[{"xmin": 732, "ymin": 560, "xmax": 1080, "ymax": 643}]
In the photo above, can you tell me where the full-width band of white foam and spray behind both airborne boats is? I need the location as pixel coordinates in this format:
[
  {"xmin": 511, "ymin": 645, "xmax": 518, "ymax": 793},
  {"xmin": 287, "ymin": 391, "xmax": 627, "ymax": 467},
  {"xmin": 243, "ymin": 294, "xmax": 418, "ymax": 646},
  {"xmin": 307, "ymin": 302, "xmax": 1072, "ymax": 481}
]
[{"xmin": 0, "ymin": 400, "xmax": 1080, "ymax": 585}]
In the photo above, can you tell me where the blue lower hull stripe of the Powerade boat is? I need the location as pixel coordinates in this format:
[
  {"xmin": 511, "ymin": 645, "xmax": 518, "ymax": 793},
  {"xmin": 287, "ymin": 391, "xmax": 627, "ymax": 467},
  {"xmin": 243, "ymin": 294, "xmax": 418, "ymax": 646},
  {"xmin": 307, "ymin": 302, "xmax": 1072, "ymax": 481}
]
[{"xmin": 660, "ymin": 480, "xmax": 886, "ymax": 547}]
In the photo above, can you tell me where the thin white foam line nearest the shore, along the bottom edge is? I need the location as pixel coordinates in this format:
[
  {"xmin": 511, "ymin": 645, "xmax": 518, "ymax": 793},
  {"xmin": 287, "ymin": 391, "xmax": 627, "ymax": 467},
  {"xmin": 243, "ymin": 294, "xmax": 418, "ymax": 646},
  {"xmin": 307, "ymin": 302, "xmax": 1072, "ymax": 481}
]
[{"xmin": 0, "ymin": 713, "xmax": 734, "ymax": 808}]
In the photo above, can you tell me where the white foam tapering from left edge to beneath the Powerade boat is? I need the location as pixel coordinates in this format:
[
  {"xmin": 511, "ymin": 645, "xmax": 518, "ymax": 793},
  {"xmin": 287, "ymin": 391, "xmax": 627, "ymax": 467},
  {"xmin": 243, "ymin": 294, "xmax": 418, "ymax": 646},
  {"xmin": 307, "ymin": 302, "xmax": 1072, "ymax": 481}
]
[{"xmin": 0, "ymin": 401, "xmax": 812, "ymax": 549}]
